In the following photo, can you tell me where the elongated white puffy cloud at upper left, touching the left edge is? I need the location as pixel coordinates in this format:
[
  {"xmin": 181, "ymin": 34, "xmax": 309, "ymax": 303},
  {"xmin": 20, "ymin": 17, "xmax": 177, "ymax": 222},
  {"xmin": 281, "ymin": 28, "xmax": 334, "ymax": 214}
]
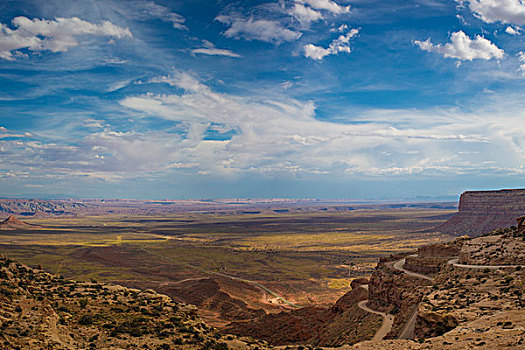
[{"xmin": 0, "ymin": 16, "xmax": 132, "ymax": 60}]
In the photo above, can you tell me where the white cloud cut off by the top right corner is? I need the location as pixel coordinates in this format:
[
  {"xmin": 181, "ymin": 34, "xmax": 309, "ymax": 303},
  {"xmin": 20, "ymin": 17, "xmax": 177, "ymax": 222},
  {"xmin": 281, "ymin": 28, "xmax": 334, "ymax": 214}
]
[{"xmin": 456, "ymin": 0, "xmax": 525, "ymax": 25}]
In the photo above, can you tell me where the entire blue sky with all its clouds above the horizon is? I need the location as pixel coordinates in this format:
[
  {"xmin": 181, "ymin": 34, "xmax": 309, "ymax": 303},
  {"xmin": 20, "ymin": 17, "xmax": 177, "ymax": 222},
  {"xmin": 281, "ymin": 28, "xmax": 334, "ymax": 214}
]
[{"xmin": 0, "ymin": 0, "xmax": 525, "ymax": 198}]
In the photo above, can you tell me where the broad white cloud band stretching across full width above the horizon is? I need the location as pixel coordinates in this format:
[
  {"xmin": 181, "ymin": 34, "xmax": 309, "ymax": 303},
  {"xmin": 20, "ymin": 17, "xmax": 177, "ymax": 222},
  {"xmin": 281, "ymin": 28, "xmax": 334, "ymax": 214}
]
[{"xmin": 5, "ymin": 72, "xmax": 525, "ymax": 180}]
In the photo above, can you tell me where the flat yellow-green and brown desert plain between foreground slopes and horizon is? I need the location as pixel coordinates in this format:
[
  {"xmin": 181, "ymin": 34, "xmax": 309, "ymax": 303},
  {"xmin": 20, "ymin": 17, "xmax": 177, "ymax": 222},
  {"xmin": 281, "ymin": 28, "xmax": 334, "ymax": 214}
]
[{"xmin": 0, "ymin": 208, "xmax": 455, "ymax": 326}]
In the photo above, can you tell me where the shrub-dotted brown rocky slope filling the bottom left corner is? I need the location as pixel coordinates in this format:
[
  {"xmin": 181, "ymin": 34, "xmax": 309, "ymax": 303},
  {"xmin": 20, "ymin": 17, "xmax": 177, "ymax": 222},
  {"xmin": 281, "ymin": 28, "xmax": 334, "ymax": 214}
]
[{"xmin": 0, "ymin": 256, "xmax": 266, "ymax": 350}]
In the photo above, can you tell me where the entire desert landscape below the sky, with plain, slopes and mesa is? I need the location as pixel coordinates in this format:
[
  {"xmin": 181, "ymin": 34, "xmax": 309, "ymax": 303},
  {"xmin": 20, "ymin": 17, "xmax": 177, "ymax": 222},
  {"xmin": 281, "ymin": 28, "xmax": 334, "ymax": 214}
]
[{"xmin": 0, "ymin": 190, "xmax": 525, "ymax": 349}]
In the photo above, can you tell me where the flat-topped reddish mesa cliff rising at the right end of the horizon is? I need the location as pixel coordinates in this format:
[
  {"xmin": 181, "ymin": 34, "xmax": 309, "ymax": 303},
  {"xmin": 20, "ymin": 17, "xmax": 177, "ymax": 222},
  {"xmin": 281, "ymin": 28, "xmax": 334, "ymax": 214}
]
[{"xmin": 435, "ymin": 189, "xmax": 525, "ymax": 236}]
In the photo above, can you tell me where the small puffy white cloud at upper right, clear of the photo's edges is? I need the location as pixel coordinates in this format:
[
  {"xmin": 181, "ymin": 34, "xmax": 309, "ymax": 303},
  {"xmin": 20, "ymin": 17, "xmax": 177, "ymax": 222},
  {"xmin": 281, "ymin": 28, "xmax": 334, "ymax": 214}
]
[{"xmin": 414, "ymin": 31, "xmax": 504, "ymax": 61}]
